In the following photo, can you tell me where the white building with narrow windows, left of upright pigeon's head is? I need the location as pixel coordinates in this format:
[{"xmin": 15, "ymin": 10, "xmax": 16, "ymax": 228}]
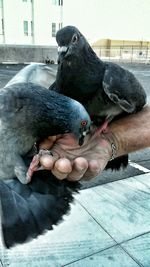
[{"xmin": 0, "ymin": 0, "xmax": 63, "ymax": 45}]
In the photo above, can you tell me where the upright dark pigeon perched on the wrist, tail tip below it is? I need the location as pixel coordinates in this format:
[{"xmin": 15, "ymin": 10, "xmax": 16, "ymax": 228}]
[{"xmin": 50, "ymin": 26, "xmax": 146, "ymax": 169}]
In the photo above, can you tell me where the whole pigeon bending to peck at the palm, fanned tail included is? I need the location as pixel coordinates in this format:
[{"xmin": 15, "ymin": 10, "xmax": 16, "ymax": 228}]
[{"xmin": 0, "ymin": 82, "xmax": 91, "ymax": 247}]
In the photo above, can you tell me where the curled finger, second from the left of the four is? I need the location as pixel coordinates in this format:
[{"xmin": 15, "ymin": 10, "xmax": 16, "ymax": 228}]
[{"xmin": 52, "ymin": 158, "xmax": 72, "ymax": 180}]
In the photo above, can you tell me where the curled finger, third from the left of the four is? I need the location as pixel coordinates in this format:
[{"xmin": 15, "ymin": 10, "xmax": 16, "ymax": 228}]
[{"xmin": 67, "ymin": 157, "xmax": 88, "ymax": 181}]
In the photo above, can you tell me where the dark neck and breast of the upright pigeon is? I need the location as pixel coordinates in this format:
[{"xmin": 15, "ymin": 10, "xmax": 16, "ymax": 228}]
[{"xmin": 56, "ymin": 45, "xmax": 104, "ymax": 104}]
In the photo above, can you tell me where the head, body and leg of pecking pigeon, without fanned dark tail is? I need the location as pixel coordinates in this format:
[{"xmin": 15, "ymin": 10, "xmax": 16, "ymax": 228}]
[{"xmin": 0, "ymin": 83, "xmax": 90, "ymax": 183}]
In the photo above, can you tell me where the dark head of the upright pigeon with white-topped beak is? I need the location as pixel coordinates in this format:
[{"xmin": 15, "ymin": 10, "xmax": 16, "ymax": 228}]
[{"xmin": 56, "ymin": 26, "xmax": 88, "ymax": 63}]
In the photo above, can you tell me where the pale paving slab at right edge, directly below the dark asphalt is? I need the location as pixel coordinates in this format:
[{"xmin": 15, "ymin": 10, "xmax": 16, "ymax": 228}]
[{"xmin": 77, "ymin": 174, "xmax": 150, "ymax": 242}]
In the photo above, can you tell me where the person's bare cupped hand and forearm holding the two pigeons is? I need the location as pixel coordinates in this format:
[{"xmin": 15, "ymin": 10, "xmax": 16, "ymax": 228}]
[{"xmin": 40, "ymin": 107, "xmax": 150, "ymax": 181}]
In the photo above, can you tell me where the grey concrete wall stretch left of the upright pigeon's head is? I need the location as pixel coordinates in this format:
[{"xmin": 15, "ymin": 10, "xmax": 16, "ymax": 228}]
[{"xmin": 0, "ymin": 45, "xmax": 57, "ymax": 63}]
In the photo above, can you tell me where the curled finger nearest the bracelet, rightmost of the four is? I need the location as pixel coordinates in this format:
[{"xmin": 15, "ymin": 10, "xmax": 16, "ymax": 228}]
[{"xmin": 83, "ymin": 160, "xmax": 102, "ymax": 181}]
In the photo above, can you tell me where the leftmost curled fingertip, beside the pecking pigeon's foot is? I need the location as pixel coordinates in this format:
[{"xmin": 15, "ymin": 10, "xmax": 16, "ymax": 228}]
[{"xmin": 40, "ymin": 153, "xmax": 59, "ymax": 170}]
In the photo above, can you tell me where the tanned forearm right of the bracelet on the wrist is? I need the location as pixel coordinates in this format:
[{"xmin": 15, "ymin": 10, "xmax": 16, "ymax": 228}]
[{"xmin": 106, "ymin": 106, "xmax": 150, "ymax": 157}]
